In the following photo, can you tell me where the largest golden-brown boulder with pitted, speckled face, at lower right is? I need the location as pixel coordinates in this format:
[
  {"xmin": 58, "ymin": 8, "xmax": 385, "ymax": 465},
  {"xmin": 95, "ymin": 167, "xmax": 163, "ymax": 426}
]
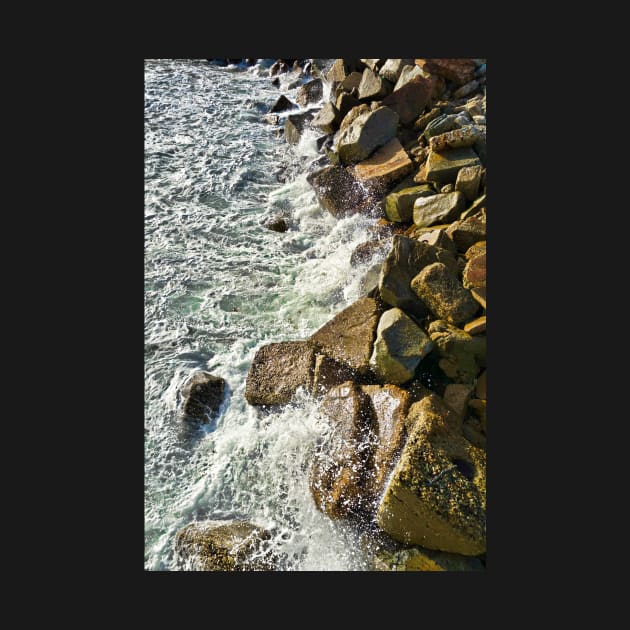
[{"xmin": 376, "ymin": 396, "xmax": 486, "ymax": 556}]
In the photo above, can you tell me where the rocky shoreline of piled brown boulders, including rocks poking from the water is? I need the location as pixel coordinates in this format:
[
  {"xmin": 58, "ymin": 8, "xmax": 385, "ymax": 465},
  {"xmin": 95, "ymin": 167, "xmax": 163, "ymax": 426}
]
[{"xmin": 176, "ymin": 59, "xmax": 487, "ymax": 571}]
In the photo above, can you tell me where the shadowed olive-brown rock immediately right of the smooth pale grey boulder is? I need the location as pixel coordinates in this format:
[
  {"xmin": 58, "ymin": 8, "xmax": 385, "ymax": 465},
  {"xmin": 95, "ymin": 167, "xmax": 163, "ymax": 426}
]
[{"xmin": 428, "ymin": 319, "xmax": 486, "ymax": 383}]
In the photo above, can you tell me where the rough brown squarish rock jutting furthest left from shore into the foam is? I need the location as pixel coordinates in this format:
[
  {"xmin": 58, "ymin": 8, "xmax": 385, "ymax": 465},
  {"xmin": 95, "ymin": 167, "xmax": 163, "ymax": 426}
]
[{"xmin": 245, "ymin": 341, "xmax": 315, "ymax": 405}]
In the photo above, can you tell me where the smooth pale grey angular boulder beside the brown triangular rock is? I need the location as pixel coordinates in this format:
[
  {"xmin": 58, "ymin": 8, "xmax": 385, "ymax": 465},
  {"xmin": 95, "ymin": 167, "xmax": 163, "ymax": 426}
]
[{"xmin": 370, "ymin": 308, "xmax": 433, "ymax": 385}]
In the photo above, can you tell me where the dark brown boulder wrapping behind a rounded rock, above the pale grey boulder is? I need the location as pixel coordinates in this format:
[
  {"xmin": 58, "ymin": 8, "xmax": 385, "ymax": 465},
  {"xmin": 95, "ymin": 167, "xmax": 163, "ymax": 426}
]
[{"xmin": 379, "ymin": 234, "xmax": 457, "ymax": 318}]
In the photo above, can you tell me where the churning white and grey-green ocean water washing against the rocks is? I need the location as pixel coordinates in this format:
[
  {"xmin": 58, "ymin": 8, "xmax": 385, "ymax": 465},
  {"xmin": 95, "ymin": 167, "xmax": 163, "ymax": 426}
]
[{"xmin": 144, "ymin": 60, "xmax": 388, "ymax": 571}]
